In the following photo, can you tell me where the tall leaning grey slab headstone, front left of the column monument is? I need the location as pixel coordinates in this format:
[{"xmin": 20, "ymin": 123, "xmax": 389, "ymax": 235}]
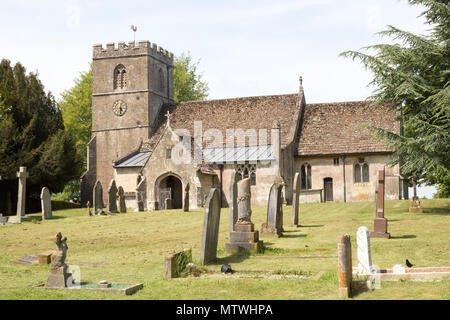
[{"xmin": 200, "ymin": 188, "xmax": 220, "ymax": 264}]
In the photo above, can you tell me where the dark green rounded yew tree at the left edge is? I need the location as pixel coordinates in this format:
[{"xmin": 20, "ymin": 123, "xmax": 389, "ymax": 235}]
[{"xmin": 0, "ymin": 59, "xmax": 80, "ymax": 211}]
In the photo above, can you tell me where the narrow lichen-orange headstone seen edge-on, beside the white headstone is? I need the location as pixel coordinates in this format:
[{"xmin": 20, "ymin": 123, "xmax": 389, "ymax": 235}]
[{"xmin": 338, "ymin": 234, "xmax": 352, "ymax": 298}]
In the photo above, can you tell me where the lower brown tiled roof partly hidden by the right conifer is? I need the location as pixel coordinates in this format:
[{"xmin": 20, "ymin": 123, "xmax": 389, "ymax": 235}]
[{"xmin": 298, "ymin": 101, "xmax": 400, "ymax": 156}]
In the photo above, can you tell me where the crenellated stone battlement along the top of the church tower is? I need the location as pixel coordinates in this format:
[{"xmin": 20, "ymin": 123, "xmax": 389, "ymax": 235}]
[{"xmin": 92, "ymin": 41, "xmax": 173, "ymax": 66}]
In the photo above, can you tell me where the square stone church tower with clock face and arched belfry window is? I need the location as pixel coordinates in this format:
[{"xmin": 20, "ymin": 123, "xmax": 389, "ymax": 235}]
[{"xmin": 81, "ymin": 41, "xmax": 174, "ymax": 206}]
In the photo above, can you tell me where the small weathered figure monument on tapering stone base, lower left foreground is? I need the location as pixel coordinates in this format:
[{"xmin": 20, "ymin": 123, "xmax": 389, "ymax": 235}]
[{"xmin": 45, "ymin": 232, "xmax": 73, "ymax": 288}]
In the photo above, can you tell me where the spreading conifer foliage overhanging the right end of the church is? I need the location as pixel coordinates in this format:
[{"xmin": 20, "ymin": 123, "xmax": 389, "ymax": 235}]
[{"xmin": 341, "ymin": 0, "xmax": 450, "ymax": 196}]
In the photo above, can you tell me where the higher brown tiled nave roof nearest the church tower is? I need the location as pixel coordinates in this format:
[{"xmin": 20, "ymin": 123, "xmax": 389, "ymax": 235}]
[{"xmin": 141, "ymin": 94, "xmax": 299, "ymax": 151}]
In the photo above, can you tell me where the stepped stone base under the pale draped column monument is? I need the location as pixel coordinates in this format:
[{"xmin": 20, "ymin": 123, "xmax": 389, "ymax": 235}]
[{"xmin": 225, "ymin": 223, "xmax": 263, "ymax": 253}]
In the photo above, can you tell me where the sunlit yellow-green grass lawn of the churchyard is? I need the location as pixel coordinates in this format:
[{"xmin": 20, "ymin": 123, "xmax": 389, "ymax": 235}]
[{"xmin": 0, "ymin": 199, "xmax": 450, "ymax": 300}]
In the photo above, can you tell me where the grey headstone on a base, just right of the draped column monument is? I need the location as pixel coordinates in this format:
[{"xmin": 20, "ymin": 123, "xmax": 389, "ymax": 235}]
[{"xmin": 261, "ymin": 183, "xmax": 283, "ymax": 237}]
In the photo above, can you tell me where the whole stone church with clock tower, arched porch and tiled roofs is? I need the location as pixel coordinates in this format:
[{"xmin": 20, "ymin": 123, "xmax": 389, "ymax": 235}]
[{"xmin": 81, "ymin": 41, "xmax": 408, "ymax": 210}]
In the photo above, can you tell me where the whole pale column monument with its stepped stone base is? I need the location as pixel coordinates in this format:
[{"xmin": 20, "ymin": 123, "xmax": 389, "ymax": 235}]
[{"xmin": 225, "ymin": 178, "xmax": 263, "ymax": 252}]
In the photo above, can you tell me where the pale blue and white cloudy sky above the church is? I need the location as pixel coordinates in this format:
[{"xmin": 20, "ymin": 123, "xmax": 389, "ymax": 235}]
[{"xmin": 0, "ymin": 0, "xmax": 435, "ymax": 198}]
